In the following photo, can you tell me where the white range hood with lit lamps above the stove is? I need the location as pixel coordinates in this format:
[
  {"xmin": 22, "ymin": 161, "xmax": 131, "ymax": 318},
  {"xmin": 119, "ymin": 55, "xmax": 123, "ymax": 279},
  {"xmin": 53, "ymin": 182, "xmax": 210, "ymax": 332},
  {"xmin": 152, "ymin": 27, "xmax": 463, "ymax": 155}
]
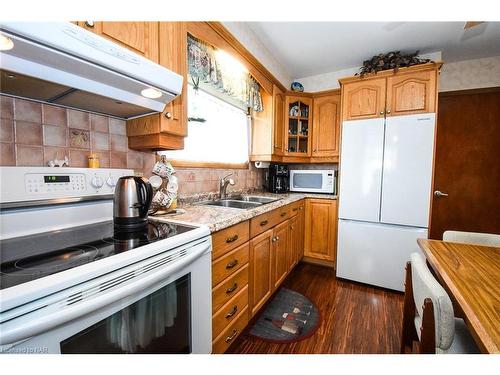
[{"xmin": 0, "ymin": 22, "xmax": 183, "ymax": 119}]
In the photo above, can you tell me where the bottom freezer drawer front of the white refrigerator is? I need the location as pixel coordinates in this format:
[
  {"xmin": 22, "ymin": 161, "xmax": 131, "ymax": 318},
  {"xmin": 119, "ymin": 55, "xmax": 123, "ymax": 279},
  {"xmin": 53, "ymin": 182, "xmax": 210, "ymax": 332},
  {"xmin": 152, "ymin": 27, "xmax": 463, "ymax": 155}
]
[{"xmin": 337, "ymin": 220, "xmax": 427, "ymax": 291}]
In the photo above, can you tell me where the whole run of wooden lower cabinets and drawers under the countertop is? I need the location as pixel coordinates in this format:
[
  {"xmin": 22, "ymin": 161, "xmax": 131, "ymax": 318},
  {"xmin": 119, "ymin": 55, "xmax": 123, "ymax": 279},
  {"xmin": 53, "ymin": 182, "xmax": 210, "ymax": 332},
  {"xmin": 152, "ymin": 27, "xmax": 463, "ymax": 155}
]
[{"xmin": 212, "ymin": 199, "xmax": 337, "ymax": 353}]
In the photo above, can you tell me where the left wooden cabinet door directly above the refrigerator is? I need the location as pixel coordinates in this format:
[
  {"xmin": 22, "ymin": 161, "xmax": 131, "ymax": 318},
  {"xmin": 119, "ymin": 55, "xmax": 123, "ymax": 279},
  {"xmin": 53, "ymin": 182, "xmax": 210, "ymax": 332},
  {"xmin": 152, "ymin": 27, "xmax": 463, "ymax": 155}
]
[{"xmin": 342, "ymin": 78, "xmax": 386, "ymax": 120}]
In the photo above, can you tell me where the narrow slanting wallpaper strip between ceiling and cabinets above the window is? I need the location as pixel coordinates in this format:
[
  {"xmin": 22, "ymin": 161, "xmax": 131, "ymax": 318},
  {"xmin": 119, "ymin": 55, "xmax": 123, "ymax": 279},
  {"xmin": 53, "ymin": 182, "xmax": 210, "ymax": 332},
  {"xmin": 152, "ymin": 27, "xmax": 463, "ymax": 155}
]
[{"xmin": 222, "ymin": 22, "xmax": 292, "ymax": 87}]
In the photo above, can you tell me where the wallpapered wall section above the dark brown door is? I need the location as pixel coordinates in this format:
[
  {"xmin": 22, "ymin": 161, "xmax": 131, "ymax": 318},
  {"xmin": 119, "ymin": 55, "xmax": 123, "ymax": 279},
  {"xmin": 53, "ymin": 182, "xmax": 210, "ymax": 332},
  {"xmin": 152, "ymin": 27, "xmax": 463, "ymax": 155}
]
[{"xmin": 439, "ymin": 56, "xmax": 500, "ymax": 91}]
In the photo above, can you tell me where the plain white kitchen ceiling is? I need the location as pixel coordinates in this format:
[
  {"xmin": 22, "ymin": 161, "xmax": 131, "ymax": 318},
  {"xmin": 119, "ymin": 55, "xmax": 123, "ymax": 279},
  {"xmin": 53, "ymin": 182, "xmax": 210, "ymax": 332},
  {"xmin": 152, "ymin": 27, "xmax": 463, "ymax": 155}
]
[{"xmin": 247, "ymin": 22, "xmax": 500, "ymax": 78}]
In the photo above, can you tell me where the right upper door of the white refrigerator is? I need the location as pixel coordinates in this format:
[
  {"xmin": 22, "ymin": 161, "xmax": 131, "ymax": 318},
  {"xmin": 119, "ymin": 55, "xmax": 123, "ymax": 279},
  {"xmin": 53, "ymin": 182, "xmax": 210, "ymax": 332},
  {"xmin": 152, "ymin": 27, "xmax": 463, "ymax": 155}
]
[{"xmin": 380, "ymin": 113, "xmax": 435, "ymax": 228}]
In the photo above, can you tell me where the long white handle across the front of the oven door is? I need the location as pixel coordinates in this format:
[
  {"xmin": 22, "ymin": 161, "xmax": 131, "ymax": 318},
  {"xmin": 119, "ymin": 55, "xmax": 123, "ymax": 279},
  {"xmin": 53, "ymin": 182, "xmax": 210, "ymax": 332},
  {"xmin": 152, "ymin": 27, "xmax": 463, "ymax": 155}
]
[{"xmin": 0, "ymin": 242, "xmax": 211, "ymax": 345}]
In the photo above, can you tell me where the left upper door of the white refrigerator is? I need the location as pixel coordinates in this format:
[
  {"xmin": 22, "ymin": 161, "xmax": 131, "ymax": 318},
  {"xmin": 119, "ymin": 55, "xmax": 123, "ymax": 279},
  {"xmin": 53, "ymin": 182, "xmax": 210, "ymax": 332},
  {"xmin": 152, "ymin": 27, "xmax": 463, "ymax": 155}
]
[{"xmin": 339, "ymin": 118, "xmax": 384, "ymax": 222}]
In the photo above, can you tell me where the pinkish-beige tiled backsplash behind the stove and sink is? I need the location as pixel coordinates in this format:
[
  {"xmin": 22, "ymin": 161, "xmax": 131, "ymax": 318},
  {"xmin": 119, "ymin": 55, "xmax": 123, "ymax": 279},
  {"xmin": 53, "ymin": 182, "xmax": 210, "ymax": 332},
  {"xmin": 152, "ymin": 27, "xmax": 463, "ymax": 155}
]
[{"xmin": 0, "ymin": 95, "xmax": 264, "ymax": 197}]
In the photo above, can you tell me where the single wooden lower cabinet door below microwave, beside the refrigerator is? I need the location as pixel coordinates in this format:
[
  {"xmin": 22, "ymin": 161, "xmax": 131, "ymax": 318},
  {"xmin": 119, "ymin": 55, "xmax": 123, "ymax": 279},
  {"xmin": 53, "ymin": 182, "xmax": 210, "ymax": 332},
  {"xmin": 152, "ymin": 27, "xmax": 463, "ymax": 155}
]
[{"xmin": 304, "ymin": 198, "xmax": 337, "ymax": 263}]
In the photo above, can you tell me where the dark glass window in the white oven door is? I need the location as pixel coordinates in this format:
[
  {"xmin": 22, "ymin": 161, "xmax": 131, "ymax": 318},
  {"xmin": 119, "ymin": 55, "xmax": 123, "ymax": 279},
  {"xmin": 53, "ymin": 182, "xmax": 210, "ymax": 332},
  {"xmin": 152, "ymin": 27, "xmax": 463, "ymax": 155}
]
[{"xmin": 61, "ymin": 274, "xmax": 191, "ymax": 354}]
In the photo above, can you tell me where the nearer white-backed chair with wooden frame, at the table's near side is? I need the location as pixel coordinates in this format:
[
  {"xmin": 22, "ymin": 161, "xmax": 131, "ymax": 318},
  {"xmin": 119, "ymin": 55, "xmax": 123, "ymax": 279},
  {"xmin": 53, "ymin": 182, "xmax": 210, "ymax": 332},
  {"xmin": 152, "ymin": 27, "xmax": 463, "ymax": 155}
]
[{"xmin": 401, "ymin": 253, "xmax": 479, "ymax": 354}]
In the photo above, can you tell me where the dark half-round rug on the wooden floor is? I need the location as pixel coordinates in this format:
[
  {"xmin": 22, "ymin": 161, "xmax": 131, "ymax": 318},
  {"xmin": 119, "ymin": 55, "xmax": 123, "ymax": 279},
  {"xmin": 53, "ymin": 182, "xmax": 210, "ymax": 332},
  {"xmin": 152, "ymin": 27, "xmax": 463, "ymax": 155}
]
[{"xmin": 249, "ymin": 288, "xmax": 321, "ymax": 343}]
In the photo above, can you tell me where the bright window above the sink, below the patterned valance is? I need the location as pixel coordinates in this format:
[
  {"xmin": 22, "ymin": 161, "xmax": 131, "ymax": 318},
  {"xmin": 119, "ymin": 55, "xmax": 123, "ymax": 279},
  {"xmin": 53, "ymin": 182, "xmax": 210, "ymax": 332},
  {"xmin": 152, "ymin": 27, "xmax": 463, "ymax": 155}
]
[{"xmin": 160, "ymin": 84, "xmax": 250, "ymax": 167}]
